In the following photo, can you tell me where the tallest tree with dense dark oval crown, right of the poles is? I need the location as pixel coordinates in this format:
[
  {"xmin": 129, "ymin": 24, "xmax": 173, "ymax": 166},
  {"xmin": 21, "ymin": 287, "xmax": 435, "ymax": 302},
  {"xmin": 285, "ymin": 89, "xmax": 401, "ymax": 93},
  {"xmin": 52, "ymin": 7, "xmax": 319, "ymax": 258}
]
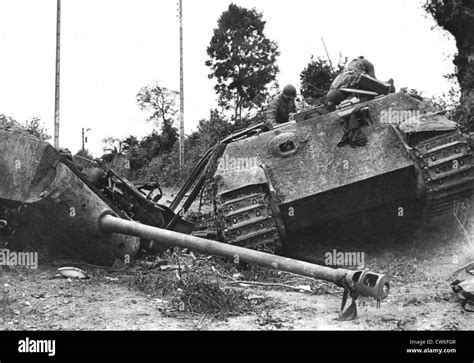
[{"xmin": 206, "ymin": 4, "xmax": 280, "ymax": 120}]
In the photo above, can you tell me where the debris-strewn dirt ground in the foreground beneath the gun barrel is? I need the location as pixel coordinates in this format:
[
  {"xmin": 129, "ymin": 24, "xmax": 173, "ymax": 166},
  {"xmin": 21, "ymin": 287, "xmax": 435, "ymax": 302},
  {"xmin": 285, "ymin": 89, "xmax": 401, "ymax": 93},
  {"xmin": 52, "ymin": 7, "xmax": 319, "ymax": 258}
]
[{"xmin": 0, "ymin": 220, "xmax": 474, "ymax": 330}]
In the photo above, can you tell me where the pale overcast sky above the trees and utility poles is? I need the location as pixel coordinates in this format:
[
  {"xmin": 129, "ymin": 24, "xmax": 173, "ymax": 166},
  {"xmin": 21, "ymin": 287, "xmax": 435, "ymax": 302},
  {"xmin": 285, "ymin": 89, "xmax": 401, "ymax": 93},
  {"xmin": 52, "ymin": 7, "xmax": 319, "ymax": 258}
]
[{"xmin": 0, "ymin": 0, "xmax": 457, "ymax": 157}]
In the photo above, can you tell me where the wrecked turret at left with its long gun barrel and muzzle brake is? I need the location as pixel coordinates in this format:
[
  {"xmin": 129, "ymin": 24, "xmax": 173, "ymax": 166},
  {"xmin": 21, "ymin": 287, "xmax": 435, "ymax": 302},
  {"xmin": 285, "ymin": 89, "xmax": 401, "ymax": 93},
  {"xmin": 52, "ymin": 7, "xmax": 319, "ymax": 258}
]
[{"xmin": 0, "ymin": 123, "xmax": 390, "ymax": 319}]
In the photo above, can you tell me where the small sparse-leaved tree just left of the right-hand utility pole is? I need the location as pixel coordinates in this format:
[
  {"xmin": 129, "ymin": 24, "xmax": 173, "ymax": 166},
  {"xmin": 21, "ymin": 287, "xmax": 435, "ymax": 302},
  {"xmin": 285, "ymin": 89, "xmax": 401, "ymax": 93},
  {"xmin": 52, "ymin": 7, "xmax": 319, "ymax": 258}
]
[{"xmin": 137, "ymin": 81, "xmax": 178, "ymax": 152}]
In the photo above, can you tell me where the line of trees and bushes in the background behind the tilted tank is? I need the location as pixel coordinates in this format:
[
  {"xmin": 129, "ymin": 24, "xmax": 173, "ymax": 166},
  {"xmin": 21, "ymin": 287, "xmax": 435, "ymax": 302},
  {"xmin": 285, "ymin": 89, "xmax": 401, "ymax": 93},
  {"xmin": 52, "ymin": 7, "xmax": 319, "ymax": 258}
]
[{"xmin": 103, "ymin": 4, "xmax": 347, "ymax": 185}]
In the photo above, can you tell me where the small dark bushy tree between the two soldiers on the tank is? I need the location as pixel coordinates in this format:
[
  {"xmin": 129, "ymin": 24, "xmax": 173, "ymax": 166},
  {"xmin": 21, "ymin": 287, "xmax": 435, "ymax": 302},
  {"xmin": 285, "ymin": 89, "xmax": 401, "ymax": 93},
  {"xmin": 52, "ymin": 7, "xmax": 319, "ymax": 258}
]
[{"xmin": 300, "ymin": 56, "xmax": 347, "ymax": 99}]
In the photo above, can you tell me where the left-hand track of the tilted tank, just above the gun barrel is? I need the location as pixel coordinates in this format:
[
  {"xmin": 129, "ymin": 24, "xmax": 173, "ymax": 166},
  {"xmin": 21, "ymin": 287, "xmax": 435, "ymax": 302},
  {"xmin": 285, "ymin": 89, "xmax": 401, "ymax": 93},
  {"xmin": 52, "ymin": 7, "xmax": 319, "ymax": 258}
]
[{"xmin": 217, "ymin": 184, "xmax": 281, "ymax": 253}]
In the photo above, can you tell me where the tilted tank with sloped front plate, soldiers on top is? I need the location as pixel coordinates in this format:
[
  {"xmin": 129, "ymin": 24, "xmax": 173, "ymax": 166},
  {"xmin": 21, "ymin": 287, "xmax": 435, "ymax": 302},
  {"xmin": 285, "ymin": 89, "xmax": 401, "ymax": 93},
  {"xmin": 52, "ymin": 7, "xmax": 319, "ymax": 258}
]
[{"xmin": 208, "ymin": 90, "xmax": 474, "ymax": 250}]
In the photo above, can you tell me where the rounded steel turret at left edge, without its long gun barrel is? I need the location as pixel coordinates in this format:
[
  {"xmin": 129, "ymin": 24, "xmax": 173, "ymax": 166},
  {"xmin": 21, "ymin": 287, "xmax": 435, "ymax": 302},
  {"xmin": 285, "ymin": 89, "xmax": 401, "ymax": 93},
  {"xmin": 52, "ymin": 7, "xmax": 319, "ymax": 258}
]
[{"xmin": 0, "ymin": 130, "xmax": 140, "ymax": 265}]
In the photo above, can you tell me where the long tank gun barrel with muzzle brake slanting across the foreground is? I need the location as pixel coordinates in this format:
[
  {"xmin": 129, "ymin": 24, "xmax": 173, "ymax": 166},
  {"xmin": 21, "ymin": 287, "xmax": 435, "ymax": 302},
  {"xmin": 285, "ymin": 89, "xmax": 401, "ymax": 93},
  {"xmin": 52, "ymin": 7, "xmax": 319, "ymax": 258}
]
[{"xmin": 99, "ymin": 214, "xmax": 390, "ymax": 300}]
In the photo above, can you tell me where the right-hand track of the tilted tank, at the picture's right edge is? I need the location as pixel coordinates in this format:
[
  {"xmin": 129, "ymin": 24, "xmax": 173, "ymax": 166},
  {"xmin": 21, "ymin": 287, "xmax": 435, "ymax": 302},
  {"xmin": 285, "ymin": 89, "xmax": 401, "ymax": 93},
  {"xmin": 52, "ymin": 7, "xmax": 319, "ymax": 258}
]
[{"xmin": 414, "ymin": 130, "xmax": 474, "ymax": 227}]
